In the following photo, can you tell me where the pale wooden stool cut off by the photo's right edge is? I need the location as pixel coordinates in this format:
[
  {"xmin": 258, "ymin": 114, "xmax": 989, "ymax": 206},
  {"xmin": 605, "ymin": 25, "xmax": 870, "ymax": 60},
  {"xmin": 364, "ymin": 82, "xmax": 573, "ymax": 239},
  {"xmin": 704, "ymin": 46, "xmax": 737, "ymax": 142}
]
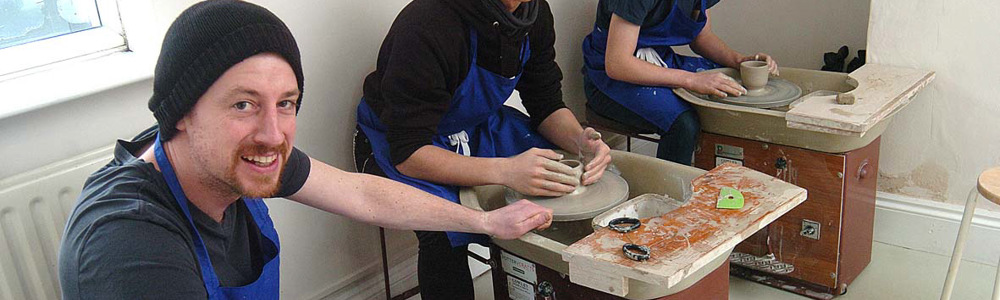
[{"xmin": 941, "ymin": 167, "xmax": 1000, "ymax": 300}]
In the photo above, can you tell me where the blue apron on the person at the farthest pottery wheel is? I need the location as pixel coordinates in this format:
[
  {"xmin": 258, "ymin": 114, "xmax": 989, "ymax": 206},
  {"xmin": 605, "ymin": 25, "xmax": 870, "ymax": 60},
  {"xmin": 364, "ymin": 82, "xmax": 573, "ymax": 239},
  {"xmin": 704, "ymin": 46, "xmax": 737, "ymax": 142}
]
[{"xmin": 583, "ymin": 0, "xmax": 721, "ymax": 131}]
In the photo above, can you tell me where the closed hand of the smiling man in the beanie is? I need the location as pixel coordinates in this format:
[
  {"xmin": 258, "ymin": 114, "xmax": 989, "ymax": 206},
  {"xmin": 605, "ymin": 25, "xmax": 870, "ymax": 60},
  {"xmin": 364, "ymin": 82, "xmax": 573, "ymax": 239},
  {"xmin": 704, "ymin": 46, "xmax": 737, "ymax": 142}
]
[{"xmin": 483, "ymin": 199, "xmax": 552, "ymax": 240}]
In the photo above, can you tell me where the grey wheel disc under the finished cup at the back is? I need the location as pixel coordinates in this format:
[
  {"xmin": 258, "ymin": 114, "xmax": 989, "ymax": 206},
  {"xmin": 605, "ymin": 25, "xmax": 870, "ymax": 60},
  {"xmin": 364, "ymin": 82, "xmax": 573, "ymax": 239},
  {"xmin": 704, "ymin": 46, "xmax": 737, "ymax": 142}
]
[{"xmin": 694, "ymin": 74, "xmax": 802, "ymax": 108}]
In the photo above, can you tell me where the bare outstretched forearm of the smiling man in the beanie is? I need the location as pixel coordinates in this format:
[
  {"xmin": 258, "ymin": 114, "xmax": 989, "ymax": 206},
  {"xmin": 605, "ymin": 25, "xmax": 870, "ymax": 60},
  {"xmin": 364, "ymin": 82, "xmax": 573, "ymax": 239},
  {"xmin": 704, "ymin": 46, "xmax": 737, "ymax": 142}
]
[{"xmin": 289, "ymin": 160, "xmax": 487, "ymax": 233}]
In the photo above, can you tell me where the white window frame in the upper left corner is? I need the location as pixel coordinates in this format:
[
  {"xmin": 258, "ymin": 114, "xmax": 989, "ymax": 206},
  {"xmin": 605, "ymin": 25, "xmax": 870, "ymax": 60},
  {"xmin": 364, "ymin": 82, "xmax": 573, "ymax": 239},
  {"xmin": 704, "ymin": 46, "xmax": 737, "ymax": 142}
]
[{"xmin": 0, "ymin": 0, "xmax": 128, "ymax": 81}]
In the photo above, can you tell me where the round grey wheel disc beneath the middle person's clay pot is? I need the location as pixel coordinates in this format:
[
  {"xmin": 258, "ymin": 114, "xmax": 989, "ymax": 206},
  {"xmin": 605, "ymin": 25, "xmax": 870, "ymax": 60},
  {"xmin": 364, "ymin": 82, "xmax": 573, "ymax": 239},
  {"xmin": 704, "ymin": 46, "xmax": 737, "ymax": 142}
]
[{"xmin": 504, "ymin": 172, "xmax": 628, "ymax": 222}]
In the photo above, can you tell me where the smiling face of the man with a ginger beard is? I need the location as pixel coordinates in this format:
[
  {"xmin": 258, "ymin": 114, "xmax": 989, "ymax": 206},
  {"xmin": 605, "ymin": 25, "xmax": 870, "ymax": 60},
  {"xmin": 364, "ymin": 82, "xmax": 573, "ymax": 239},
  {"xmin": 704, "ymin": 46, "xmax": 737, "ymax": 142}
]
[{"xmin": 174, "ymin": 53, "xmax": 300, "ymax": 197}]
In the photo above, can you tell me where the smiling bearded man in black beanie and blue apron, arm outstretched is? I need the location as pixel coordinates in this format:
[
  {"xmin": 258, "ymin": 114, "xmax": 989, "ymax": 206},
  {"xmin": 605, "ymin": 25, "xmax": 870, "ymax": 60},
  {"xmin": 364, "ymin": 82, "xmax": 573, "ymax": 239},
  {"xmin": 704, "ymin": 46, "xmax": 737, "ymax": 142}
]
[{"xmin": 59, "ymin": 0, "xmax": 551, "ymax": 299}]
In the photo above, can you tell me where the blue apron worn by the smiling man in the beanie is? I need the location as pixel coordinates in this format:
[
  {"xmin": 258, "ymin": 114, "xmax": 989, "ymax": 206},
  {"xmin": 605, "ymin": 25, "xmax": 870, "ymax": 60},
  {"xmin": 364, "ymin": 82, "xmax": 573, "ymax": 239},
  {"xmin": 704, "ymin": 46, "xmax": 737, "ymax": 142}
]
[{"xmin": 153, "ymin": 134, "xmax": 279, "ymax": 299}]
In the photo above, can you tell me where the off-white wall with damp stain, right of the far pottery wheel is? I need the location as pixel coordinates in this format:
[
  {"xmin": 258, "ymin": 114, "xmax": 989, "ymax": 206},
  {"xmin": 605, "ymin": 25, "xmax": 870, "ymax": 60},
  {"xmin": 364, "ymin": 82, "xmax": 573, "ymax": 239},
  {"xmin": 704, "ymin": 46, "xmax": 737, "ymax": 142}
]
[{"xmin": 868, "ymin": 0, "xmax": 1000, "ymax": 211}]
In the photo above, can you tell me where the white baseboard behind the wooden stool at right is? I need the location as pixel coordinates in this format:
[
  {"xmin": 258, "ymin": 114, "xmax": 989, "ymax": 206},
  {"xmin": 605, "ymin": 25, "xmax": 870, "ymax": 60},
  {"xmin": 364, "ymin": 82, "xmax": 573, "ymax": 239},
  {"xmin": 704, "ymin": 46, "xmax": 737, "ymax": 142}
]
[{"xmin": 874, "ymin": 192, "xmax": 1000, "ymax": 266}]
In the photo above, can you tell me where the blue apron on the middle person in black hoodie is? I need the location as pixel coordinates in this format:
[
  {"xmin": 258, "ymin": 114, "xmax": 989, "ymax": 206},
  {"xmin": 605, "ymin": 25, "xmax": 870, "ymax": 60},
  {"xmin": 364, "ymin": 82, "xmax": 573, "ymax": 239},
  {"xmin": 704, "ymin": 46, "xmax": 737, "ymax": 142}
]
[{"xmin": 358, "ymin": 28, "xmax": 555, "ymax": 247}]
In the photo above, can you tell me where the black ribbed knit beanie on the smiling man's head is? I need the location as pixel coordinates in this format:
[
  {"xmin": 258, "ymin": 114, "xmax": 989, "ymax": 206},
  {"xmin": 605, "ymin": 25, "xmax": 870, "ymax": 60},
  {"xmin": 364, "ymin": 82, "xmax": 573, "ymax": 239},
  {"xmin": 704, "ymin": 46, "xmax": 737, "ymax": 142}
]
[{"xmin": 149, "ymin": 0, "xmax": 302, "ymax": 141}]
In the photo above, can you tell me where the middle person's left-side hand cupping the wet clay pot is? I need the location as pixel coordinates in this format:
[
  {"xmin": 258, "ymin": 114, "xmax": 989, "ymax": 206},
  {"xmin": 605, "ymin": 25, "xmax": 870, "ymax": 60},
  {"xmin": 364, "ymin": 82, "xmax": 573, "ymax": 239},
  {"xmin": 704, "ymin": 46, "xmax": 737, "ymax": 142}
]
[{"xmin": 501, "ymin": 148, "xmax": 580, "ymax": 197}]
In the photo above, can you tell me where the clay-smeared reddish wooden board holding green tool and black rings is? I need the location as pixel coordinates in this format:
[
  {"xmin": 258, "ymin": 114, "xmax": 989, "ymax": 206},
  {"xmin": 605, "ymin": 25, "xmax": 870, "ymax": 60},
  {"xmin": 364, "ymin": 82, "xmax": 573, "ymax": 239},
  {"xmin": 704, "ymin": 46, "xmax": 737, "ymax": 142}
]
[{"xmin": 562, "ymin": 164, "xmax": 806, "ymax": 295}]
